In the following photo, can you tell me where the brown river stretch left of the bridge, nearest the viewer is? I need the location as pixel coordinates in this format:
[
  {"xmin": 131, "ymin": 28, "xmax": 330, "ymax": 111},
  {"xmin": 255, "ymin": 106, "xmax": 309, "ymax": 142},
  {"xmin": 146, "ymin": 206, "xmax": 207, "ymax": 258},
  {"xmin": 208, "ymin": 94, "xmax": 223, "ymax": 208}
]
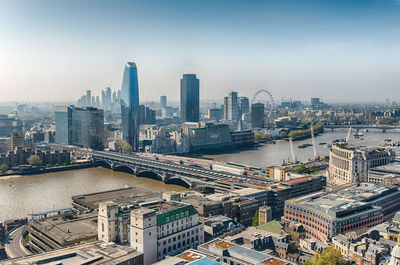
[{"xmin": 0, "ymin": 167, "xmax": 186, "ymax": 222}]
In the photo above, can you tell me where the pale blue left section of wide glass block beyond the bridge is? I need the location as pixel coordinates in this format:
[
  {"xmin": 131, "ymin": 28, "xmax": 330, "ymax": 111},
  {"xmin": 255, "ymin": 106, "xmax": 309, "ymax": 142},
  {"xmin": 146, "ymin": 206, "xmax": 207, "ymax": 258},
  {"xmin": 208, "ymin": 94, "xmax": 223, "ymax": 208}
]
[{"xmin": 54, "ymin": 106, "xmax": 72, "ymax": 144}]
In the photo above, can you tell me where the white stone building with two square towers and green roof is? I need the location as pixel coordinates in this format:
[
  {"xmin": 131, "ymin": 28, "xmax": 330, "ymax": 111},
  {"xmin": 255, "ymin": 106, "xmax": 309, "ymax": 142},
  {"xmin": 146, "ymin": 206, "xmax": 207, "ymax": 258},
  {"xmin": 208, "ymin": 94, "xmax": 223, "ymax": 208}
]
[{"xmin": 98, "ymin": 198, "xmax": 204, "ymax": 265}]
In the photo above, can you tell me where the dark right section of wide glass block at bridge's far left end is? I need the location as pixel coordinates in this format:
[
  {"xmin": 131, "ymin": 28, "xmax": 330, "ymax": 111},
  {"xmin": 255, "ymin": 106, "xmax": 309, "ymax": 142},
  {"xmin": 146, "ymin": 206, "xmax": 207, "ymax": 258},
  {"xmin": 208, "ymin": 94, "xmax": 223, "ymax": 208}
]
[{"xmin": 71, "ymin": 107, "xmax": 104, "ymax": 150}]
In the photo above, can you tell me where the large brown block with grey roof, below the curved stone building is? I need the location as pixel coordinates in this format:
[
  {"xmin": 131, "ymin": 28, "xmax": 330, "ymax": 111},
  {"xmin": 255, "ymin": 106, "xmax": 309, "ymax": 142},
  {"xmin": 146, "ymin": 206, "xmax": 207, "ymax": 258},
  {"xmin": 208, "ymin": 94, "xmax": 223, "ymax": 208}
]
[{"xmin": 284, "ymin": 183, "xmax": 400, "ymax": 241}]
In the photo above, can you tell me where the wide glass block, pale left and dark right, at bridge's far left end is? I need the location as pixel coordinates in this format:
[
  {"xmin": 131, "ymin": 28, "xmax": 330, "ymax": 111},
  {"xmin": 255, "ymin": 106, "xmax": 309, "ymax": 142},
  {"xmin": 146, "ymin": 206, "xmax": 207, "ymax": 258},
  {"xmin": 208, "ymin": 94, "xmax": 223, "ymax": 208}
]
[{"xmin": 55, "ymin": 106, "xmax": 104, "ymax": 150}]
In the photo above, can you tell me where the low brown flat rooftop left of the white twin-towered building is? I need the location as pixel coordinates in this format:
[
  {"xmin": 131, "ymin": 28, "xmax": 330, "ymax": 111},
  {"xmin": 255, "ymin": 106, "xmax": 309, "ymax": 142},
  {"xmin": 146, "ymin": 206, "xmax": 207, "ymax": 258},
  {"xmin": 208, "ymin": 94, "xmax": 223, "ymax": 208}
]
[{"xmin": 29, "ymin": 212, "xmax": 98, "ymax": 245}]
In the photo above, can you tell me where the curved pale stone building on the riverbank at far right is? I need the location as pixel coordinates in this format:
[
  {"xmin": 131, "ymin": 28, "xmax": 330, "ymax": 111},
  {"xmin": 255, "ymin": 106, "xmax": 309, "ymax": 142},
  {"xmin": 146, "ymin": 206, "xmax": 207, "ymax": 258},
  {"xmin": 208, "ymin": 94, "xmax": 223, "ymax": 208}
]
[{"xmin": 329, "ymin": 143, "xmax": 395, "ymax": 185}]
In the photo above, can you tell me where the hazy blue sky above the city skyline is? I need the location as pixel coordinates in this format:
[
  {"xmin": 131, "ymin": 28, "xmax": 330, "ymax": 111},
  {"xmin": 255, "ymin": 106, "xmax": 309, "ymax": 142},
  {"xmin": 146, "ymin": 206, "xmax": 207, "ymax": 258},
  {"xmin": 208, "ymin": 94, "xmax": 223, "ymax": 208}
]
[{"xmin": 0, "ymin": 0, "xmax": 400, "ymax": 102}]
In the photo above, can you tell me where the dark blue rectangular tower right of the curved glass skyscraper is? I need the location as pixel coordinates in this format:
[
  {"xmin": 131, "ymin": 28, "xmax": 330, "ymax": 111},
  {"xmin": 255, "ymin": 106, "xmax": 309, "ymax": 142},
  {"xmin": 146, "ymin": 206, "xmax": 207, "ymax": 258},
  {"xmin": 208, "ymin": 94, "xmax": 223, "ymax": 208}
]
[{"xmin": 181, "ymin": 74, "xmax": 200, "ymax": 123}]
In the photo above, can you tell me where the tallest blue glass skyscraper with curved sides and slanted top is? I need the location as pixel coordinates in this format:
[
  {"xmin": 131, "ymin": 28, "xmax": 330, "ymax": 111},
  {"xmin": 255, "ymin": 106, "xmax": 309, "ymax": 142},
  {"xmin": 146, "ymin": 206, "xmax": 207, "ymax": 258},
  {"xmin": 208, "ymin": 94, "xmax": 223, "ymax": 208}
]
[{"xmin": 120, "ymin": 62, "xmax": 139, "ymax": 151}]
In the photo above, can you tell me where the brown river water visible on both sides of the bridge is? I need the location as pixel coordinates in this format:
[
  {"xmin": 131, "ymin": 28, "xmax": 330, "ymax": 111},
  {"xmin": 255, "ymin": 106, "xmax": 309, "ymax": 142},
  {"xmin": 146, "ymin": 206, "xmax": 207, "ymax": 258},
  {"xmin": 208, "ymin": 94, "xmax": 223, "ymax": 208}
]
[{"xmin": 0, "ymin": 129, "xmax": 400, "ymax": 222}]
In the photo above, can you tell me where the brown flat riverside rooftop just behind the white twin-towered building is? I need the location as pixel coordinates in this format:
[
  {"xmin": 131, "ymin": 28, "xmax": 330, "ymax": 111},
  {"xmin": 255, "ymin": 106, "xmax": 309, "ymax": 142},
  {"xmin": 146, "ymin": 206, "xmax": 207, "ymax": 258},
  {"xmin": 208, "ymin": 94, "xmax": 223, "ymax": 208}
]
[{"xmin": 72, "ymin": 187, "xmax": 161, "ymax": 210}]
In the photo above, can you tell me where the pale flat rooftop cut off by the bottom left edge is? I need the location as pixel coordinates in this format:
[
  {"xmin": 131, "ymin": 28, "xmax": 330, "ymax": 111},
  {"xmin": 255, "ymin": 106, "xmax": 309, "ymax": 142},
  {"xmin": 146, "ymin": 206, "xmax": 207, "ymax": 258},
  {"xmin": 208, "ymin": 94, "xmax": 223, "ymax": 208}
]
[{"xmin": 2, "ymin": 242, "xmax": 142, "ymax": 265}]
